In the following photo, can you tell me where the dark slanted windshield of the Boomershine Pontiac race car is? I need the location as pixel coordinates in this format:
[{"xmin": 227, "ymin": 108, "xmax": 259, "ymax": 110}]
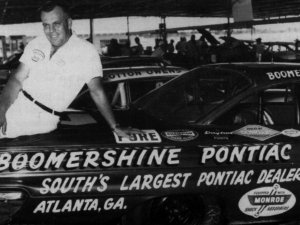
[{"xmin": 135, "ymin": 68, "xmax": 251, "ymax": 124}]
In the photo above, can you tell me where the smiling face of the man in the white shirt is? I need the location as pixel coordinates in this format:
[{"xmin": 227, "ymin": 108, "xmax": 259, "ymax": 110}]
[{"xmin": 41, "ymin": 6, "xmax": 72, "ymax": 48}]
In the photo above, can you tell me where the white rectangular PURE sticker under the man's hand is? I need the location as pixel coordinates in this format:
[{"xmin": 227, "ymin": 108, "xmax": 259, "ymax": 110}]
[{"xmin": 113, "ymin": 130, "xmax": 161, "ymax": 144}]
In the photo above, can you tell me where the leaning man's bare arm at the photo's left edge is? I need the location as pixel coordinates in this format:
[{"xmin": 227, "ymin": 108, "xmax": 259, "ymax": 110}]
[{"xmin": 0, "ymin": 63, "xmax": 29, "ymax": 134}]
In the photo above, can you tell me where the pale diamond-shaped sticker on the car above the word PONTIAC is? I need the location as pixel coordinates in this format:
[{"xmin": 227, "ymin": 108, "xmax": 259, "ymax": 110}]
[{"xmin": 233, "ymin": 125, "xmax": 280, "ymax": 141}]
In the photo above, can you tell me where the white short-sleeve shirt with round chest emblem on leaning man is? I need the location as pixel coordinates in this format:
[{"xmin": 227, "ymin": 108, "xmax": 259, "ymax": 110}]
[{"xmin": 20, "ymin": 34, "xmax": 102, "ymax": 111}]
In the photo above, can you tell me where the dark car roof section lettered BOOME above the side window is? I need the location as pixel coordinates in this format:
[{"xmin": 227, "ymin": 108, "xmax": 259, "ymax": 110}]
[{"xmin": 203, "ymin": 62, "xmax": 300, "ymax": 85}]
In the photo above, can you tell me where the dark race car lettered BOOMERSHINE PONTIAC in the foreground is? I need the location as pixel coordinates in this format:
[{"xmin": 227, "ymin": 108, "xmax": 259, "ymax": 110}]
[{"xmin": 0, "ymin": 63, "xmax": 300, "ymax": 225}]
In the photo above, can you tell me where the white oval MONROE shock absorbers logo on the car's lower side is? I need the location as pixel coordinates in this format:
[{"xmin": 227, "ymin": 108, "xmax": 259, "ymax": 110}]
[{"xmin": 239, "ymin": 184, "xmax": 296, "ymax": 218}]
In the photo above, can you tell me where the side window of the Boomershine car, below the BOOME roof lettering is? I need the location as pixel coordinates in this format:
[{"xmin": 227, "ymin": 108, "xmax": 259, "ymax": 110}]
[{"xmin": 214, "ymin": 85, "xmax": 299, "ymax": 125}]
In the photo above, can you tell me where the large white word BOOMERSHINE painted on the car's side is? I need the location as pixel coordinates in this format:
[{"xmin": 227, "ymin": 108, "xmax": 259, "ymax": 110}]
[{"xmin": 0, "ymin": 148, "xmax": 181, "ymax": 171}]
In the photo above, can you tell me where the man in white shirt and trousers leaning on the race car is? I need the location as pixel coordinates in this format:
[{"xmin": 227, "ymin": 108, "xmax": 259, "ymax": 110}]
[{"xmin": 0, "ymin": 1, "xmax": 127, "ymax": 138}]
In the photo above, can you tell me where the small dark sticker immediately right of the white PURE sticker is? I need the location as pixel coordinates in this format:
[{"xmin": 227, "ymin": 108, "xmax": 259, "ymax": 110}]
[{"xmin": 161, "ymin": 130, "xmax": 198, "ymax": 141}]
